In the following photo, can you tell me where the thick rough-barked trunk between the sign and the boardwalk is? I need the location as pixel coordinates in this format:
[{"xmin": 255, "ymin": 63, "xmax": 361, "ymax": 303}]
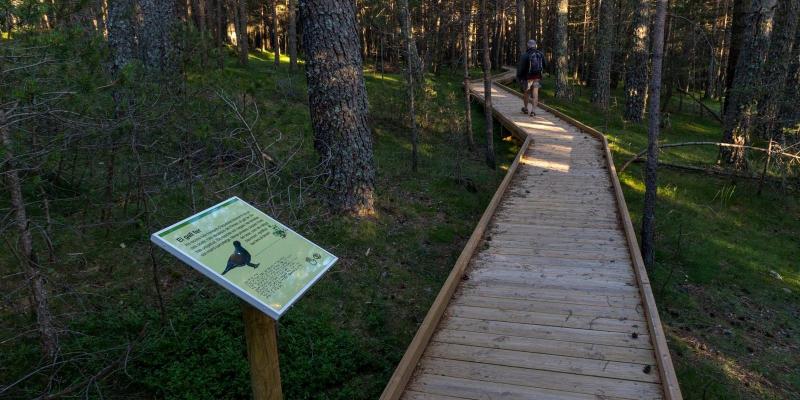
[{"xmin": 300, "ymin": 0, "xmax": 375, "ymax": 215}]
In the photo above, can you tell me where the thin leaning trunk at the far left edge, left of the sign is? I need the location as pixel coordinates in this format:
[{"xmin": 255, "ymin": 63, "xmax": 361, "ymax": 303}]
[{"xmin": 0, "ymin": 110, "xmax": 58, "ymax": 361}]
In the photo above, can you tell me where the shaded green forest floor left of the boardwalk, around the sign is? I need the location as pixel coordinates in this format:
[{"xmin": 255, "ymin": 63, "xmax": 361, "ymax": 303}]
[{"xmin": 0, "ymin": 48, "xmax": 519, "ymax": 399}]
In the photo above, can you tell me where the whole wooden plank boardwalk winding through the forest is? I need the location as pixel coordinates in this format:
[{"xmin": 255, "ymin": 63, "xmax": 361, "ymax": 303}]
[{"xmin": 382, "ymin": 77, "xmax": 681, "ymax": 400}]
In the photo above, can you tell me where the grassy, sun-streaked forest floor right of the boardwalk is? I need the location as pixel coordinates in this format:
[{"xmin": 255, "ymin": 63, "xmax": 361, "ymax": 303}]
[{"xmin": 532, "ymin": 78, "xmax": 800, "ymax": 399}]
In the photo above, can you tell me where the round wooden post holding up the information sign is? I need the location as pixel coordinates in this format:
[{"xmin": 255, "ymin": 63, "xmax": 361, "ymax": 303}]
[{"xmin": 242, "ymin": 303, "xmax": 283, "ymax": 400}]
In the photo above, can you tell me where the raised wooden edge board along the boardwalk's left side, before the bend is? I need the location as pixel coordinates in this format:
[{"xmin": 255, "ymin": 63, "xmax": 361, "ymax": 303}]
[{"xmin": 381, "ymin": 137, "xmax": 531, "ymax": 400}]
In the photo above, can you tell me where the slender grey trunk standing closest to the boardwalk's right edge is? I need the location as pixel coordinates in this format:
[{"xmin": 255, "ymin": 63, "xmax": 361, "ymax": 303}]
[{"xmin": 642, "ymin": 0, "xmax": 668, "ymax": 268}]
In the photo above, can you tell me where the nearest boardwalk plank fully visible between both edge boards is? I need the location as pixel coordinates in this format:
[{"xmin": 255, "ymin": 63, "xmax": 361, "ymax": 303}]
[{"xmin": 420, "ymin": 357, "xmax": 662, "ymax": 400}]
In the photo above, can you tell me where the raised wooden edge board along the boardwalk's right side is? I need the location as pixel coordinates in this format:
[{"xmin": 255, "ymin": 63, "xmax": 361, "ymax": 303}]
[{"xmin": 495, "ymin": 76, "xmax": 683, "ymax": 400}]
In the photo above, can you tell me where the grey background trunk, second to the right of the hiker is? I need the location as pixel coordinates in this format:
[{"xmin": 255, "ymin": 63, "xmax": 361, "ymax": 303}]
[{"xmin": 592, "ymin": 0, "xmax": 616, "ymax": 109}]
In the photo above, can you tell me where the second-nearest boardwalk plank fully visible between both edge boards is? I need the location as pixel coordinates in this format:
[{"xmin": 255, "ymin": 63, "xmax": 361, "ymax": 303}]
[{"xmin": 425, "ymin": 342, "xmax": 659, "ymax": 383}]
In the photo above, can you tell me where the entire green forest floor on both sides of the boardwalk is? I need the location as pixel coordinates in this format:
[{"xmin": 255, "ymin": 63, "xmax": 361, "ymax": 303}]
[{"xmin": 0, "ymin": 47, "xmax": 800, "ymax": 400}]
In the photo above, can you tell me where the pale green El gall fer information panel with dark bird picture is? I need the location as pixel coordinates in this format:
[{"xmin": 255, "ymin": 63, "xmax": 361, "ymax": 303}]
[{"xmin": 150, "ymin": 197, "xmax": 337, "ymax": 319}]
